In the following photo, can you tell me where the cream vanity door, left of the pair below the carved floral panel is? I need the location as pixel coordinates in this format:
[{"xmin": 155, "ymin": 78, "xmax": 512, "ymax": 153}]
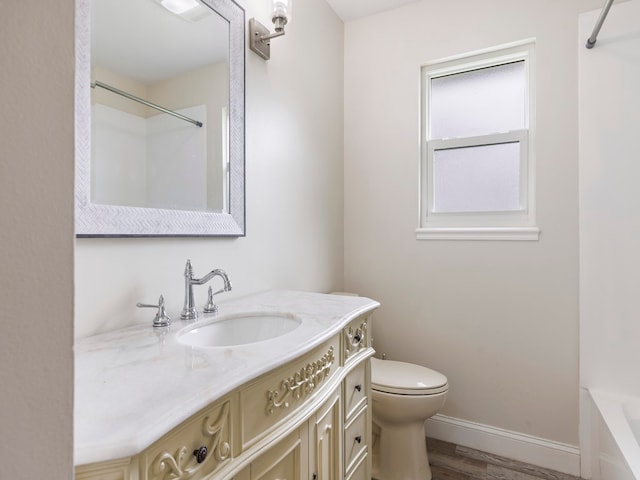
[{"xmin": 250, "ymin": 427, "xmax": 309, "ymax": 480}]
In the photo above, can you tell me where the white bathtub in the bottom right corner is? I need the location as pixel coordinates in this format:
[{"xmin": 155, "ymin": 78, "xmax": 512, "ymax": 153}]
[{"xmin": 589, "ymin": 390, "xmax": 640, "ymax": 480}]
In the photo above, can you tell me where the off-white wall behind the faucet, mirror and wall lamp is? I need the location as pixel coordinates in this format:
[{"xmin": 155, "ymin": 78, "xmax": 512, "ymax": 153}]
[{"xmin": 75, "ymin": 0, "xmax": 343, "ymax": 337}]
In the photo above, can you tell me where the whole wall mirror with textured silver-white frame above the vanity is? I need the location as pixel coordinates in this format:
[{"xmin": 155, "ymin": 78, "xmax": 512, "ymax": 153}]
[{"xmin": 75, "ymin": 0, "xmax": 245, "ymax": 237}]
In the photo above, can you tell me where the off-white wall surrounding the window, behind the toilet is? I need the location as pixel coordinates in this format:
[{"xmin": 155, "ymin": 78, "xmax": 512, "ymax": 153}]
[{"xmin": 344, "ymin": 0, "xmax": 601, "ymax": 448}]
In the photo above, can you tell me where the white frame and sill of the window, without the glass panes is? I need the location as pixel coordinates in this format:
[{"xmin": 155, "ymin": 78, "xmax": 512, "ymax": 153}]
[{"xmin": 416, "ymin": 40, "xmax": 540, "ymax": 240}]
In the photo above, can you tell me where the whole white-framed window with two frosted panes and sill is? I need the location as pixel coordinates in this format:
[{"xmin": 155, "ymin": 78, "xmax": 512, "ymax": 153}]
[{"xmin": 417, "ymin": 41, "xmax": 539, "ymax": 240}]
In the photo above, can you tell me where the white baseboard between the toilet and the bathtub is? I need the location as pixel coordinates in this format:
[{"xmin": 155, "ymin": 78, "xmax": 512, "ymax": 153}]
[{"xmin": 425, "ymin": 414, "xmax": 580, "ymax": 477}]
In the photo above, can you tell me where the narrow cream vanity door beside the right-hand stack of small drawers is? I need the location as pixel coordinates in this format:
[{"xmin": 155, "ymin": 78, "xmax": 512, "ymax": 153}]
[{"xmin": 309, "ymin": 392, "xmax": 342, "ymax": 480}]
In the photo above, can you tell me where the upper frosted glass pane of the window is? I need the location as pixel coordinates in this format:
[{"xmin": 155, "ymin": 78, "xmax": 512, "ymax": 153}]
[{"xmin": 431, "ymin": 61, "xmax": 526, "ymax": 138}]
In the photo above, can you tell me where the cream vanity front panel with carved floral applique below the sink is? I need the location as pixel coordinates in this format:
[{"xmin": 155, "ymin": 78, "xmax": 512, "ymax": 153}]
[{"xmin": 240, "ymin": 335, "xmax": 340, "ymax": 450}]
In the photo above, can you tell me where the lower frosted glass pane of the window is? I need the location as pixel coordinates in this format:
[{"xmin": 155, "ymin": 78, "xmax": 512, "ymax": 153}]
[{"xmin": 433, "ymin": 142, "xmax": 520, "ymax": 212}]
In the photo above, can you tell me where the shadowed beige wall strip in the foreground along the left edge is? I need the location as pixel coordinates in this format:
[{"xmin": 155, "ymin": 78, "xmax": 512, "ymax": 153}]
[{"xmin": 0, "ymin": 0, "xmax": 75, "ymax": 479}]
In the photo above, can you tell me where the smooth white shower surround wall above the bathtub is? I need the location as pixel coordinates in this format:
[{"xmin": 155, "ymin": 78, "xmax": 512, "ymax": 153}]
[{"xmin": 580, "ymin": 0, "xmax": 640, "ymax": 397}]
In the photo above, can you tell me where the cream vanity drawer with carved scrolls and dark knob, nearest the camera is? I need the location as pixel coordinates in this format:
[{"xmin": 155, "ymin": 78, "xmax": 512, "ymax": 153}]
[{"xmin": 140, "ymin": 399, "xmax": 232, "ymax": 480}]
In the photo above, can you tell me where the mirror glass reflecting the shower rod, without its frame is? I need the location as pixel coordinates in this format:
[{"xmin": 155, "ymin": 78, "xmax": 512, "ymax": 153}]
[{"xmin": 90, "ymin": 0, "xmax": 229, "ymax": 213}]
